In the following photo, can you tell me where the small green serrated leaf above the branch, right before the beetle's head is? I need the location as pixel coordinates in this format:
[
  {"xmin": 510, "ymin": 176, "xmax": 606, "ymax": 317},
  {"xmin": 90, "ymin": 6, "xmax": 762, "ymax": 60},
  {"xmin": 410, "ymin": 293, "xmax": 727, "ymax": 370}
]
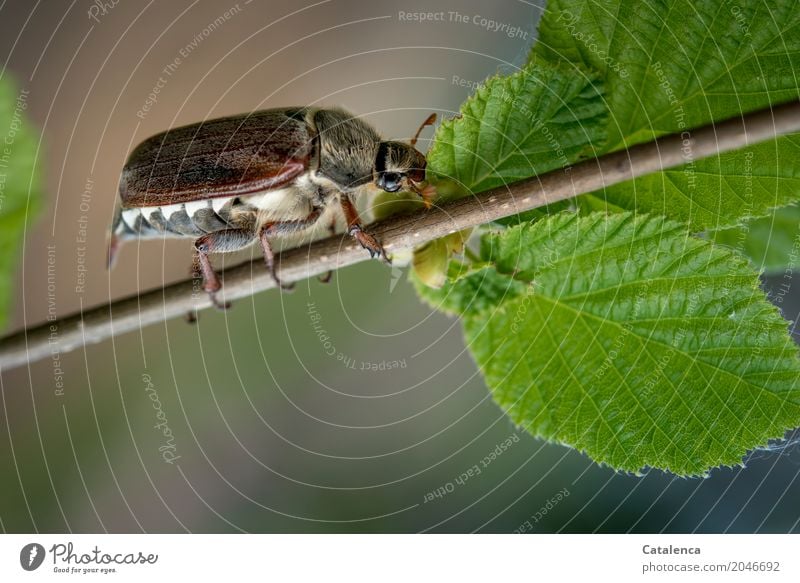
[{"xmin": 428, "ymin": 63, "xmax": 605, "ymax": 193}]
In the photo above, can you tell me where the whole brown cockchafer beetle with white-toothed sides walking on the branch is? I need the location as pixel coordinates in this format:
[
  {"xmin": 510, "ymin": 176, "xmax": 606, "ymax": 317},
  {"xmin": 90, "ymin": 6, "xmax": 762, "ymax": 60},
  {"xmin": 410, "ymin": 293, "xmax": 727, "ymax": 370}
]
[{"xmin": 109, "ymin": 107, "xmax": 436, "ymax": 308}]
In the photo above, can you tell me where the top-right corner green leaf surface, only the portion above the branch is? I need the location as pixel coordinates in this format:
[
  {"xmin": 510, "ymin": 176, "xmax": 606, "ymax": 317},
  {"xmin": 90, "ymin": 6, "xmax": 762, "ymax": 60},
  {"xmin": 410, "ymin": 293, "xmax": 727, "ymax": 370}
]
[{"xmin": 532, "ymin": 0, "xmax": 800, "ymax": 149}]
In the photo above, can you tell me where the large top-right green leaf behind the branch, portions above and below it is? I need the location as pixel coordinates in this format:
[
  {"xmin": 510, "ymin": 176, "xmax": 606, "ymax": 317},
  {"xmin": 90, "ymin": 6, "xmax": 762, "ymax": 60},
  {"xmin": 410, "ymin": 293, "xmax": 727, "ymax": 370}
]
[{"xmin": 531, "ymin": 0, "xmax": 800, "ymax": 232}]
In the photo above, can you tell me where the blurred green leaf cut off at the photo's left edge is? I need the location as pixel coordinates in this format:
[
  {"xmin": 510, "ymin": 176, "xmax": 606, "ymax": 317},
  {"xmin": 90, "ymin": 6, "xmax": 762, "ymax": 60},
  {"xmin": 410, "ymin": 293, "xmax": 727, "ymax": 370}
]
[{"xmin": 0, "ymin": 74, "xmax": 40, "ymax": 328}]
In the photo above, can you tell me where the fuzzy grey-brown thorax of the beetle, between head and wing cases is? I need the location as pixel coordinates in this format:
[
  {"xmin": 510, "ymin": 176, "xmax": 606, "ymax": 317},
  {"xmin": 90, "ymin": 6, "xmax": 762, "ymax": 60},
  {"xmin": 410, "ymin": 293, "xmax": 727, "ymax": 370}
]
[{"xmin": 313, "ymin": 109, "xmax": 381, "ymax": 191}]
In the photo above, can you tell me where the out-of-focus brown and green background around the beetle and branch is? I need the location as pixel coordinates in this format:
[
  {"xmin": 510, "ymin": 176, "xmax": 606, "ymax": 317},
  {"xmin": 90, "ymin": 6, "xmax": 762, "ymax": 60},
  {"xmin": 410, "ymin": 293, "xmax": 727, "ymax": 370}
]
[{"xmin": 0, "ymin": 0, "xmax": 800, "ymax": 532}]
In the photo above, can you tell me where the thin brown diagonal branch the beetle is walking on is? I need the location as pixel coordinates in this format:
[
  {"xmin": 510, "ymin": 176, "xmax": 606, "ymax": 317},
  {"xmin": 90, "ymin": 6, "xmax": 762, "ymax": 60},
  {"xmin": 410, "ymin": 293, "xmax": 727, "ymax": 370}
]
[{"xmin": 0, "ymin": 102, "xmax": 800, "ymax": 371}]
